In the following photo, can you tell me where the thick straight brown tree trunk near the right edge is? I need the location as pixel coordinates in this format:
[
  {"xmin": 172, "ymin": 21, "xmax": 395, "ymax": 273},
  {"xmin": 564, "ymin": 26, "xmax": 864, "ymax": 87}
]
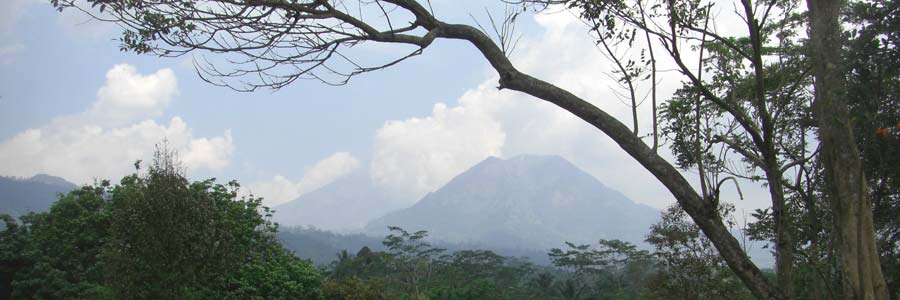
[{"xmin": 807, "ymin": 0, "xmax": 890, "ymax": 300}]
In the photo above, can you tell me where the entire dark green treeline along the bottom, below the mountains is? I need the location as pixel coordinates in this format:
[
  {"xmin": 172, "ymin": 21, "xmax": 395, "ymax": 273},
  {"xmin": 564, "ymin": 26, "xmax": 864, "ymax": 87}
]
[{"xmin": 0, "ymin": 147, "xmax": 895, "ymax": 300}]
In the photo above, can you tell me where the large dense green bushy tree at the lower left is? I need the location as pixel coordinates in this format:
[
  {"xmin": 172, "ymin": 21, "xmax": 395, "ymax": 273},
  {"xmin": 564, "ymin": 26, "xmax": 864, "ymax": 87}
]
[{"xmin": 0, "ymin": 144, "xmax": 323, "ymax": 300}]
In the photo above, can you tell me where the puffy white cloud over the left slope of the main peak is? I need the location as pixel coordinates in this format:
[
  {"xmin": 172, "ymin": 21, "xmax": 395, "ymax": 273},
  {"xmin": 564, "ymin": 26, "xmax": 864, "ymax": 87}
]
[{"xmin": 370, "ymin": 103, "xmax": 506, "ymax": 199}]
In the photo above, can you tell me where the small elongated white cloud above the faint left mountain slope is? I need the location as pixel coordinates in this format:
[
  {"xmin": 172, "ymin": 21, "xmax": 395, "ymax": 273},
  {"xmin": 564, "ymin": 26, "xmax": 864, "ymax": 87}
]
[{"xmin": 250, "ymin": 152, "xmax": 359, "ymax": 207}]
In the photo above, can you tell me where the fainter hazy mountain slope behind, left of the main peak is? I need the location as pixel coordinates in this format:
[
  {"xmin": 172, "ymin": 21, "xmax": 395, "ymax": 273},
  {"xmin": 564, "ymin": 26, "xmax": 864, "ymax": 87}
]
[{"xmin": 274, "ymin": 172, "xmax": 403, "ymax": 232}]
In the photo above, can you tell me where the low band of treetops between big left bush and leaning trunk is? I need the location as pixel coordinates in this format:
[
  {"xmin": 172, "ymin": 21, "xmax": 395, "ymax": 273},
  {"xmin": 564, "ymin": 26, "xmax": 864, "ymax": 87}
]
[{"xmin": 312, "ymin": 224, "xmax": 768, "ymax": 300}]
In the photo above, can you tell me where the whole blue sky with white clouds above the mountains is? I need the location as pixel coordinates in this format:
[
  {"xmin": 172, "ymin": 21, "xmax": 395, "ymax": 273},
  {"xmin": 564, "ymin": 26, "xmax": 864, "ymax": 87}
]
[{"xmin": 0, "ymin": 0, "xmax": 769, "ymax": 227}]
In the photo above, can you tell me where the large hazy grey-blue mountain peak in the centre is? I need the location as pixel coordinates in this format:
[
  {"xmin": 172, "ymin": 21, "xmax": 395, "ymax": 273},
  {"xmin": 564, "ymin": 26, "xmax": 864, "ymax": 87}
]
[{"xmin": 366, "ymin": 155, "xmax": 660, "ymax": 249}]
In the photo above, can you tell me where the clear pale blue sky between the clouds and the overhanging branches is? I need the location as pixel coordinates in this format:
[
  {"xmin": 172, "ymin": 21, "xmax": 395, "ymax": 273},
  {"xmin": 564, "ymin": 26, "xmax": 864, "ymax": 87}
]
[{"xmin": 0, "ymin": 0, "xmax": 506, "ymax": 199}]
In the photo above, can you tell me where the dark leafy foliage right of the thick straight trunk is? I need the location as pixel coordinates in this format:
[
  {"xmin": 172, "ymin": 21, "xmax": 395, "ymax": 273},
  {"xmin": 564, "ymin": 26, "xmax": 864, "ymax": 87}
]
[{"xmin": 844, "ymin": 0, "xmax": 900, "ymax": 299}]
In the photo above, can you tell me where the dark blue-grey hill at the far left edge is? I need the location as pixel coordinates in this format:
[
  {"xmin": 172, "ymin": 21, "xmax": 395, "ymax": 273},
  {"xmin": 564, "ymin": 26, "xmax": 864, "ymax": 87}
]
[{"xmin": 0, "ymin": 174, "xmax": 78, "ymax": 217}]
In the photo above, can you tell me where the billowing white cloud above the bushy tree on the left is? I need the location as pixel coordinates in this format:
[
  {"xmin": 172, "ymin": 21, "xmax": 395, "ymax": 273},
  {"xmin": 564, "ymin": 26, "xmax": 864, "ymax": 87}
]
[{"xmin": 0, "ymin": 65, "xmax": 234, "ymax": 183}]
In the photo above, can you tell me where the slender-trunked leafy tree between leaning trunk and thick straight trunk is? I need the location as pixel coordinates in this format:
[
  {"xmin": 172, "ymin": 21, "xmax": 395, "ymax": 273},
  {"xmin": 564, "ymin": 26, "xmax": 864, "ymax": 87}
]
[{"xmin": 540, "ymin": 0, "xmax": 815, "ymax": 297}]
